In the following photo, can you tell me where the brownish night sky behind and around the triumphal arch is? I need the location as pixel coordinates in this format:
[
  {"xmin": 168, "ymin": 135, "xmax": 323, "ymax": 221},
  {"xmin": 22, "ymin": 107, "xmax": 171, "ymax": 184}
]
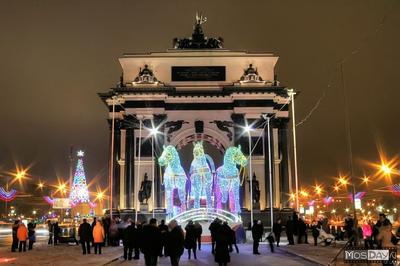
[{"xmin": 0, "ymin": 0, "xmax": 400, "ymax": 191}]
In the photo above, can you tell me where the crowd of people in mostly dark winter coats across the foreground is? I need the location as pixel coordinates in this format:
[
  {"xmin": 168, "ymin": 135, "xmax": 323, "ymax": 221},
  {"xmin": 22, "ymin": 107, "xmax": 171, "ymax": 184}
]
[{"xmin": 11, "ymin": 212, "xmax": 400, "ymax": 265}]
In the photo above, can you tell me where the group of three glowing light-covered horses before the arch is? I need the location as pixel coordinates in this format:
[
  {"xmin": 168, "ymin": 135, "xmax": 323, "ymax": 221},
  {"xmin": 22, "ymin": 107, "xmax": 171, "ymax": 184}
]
[{"xmin": 158, "ymin": 141, "xmax": 247, "ymax": 218}]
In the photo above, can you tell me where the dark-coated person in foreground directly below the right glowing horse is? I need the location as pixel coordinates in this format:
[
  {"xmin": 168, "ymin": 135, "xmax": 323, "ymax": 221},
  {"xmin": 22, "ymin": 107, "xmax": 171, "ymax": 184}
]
[{"xmin": 215, "ymin": 223, "xmax": 232, "ymax": 266}]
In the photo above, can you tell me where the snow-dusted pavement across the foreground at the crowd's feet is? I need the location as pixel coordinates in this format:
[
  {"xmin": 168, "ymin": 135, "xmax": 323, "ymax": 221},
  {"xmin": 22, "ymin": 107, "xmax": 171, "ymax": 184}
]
[{"xmin": 0, "ymin": 243, "xmax": 316, "ymax": 266}]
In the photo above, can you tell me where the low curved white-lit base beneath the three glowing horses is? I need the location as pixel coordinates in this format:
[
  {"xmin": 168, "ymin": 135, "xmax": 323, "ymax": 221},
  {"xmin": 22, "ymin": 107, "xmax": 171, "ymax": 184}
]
[{"xmin": 167, "ymin": 208, "xmax": 242, "ymax": 224}]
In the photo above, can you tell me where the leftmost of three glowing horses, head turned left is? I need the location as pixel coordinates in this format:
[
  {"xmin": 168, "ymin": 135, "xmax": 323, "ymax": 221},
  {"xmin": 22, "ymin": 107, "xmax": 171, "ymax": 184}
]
[{"xmin": 158, "ymin": 145, "xmax": 187, "ymax": 217}]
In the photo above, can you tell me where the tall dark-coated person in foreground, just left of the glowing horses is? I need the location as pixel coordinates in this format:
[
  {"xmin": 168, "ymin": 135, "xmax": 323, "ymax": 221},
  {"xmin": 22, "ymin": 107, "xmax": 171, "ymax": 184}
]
[{"xmin": 141, "ymin": 218, "xmax": 161, "ymax": 265}]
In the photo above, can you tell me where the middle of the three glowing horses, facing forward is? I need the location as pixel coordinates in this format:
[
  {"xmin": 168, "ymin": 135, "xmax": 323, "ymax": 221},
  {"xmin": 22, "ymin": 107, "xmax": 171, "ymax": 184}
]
[{"xmin": 190, "ymin": 141, "xmax": 215, "ymax": 209}]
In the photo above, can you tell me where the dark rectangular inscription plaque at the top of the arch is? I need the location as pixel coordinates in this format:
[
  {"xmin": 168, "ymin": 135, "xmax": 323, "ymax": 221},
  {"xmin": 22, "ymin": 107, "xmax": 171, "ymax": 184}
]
[{"xmin": 171, "ymin": 66, "xmax": 226, "ymax": 81}]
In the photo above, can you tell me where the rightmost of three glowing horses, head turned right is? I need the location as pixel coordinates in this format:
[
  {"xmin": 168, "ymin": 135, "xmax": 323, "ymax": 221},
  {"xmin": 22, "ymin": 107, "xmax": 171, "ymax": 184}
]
[{"xmin": 215, "ymin": 145, "xmax": 247, "ymax": 214}]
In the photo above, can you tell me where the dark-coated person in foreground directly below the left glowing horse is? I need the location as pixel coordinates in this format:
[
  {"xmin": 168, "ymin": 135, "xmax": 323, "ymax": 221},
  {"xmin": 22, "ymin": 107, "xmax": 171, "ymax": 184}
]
[{"xmin": 165, "ymin": 220, "xmax": 185, "ymax": 266}]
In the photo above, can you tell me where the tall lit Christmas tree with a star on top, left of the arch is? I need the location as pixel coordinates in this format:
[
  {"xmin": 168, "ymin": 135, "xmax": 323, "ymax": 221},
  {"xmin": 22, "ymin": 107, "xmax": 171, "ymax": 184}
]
[{"xmin": 69, "ymin": 151, "xmax": 90, "ymax": 205}]
